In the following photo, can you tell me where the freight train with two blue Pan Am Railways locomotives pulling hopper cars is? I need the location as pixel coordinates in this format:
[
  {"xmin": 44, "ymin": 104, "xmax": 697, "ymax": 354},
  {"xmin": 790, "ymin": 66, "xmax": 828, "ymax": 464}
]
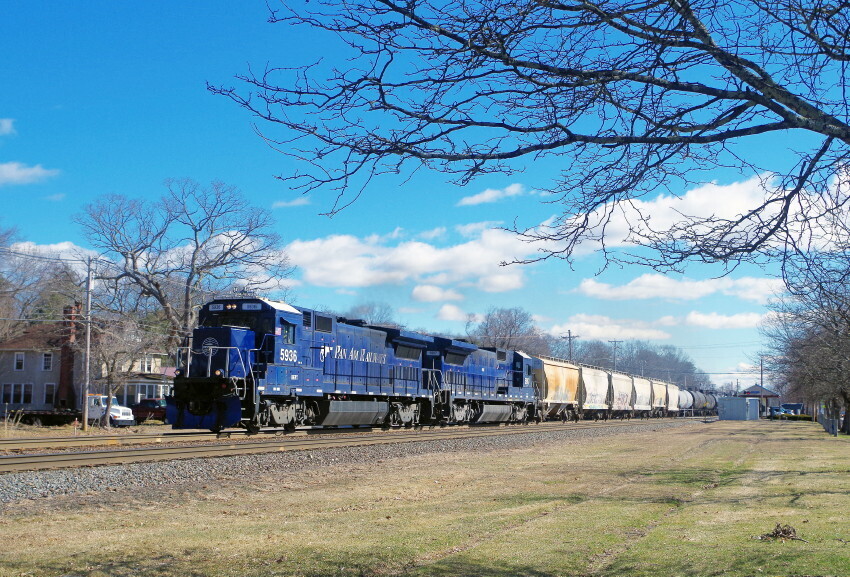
[{"xmin": 167, "ymin": 298, "xmax": 716, "ymax": 431}]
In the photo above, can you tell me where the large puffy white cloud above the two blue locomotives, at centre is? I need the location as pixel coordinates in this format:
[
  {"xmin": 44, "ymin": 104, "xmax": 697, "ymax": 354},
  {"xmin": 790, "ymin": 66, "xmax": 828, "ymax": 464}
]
[{"xmin": 286, "ymin": 229, "xmax": 535, "ymax": 292}]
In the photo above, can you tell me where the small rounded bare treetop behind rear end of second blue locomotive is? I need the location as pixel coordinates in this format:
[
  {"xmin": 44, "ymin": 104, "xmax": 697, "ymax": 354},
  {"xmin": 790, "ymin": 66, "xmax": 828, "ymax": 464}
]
[{"xmin": 466, "ymin": 308, "xmax": 551, "ymax": 355}]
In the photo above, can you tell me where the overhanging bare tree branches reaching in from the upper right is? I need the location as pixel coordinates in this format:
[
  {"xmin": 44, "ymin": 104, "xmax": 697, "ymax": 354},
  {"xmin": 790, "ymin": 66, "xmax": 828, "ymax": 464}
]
[{"xmin": 210, "ymin": 0, "xmax": 850, "ymax": 269}]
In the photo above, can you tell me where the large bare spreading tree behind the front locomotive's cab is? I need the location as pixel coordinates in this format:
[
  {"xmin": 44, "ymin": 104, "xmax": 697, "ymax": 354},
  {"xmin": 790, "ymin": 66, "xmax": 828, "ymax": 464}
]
[{"xmin": 76, "ymin": 179, "xmax": 292, "ymax": 347}]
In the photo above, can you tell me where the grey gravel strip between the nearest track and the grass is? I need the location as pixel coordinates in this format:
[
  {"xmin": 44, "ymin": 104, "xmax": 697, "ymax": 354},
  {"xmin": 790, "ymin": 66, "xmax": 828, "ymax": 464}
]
[{"xmin": 0, "ymin": 421, "xmax": 704, "ymax": 504}]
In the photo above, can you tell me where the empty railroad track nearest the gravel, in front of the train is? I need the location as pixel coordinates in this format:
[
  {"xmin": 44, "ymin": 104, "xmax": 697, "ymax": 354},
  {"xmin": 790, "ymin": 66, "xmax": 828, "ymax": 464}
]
[{"xmin": 0, "ymin": 420, "xmax": 684, "ymax": 474}]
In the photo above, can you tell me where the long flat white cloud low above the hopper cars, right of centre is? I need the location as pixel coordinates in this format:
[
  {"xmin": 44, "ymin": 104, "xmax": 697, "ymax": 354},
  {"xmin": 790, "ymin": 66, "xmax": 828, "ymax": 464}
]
[{"xmin": 577, "ymin": 274, "xmax": 783, "ymax": 304}]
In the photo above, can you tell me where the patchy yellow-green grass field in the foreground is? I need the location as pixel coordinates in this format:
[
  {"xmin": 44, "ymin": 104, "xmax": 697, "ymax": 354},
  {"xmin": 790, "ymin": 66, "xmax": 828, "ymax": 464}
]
[{"xmin": 0, "ymin": 421, "xmax": 850, "ymax": 577}]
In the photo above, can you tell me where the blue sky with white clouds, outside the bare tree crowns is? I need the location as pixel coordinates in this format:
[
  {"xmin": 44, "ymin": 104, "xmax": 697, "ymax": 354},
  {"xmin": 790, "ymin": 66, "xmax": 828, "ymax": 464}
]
[{"xmin": 0, "ymin": 0, "xmax": 779, "ymax": 385}]
